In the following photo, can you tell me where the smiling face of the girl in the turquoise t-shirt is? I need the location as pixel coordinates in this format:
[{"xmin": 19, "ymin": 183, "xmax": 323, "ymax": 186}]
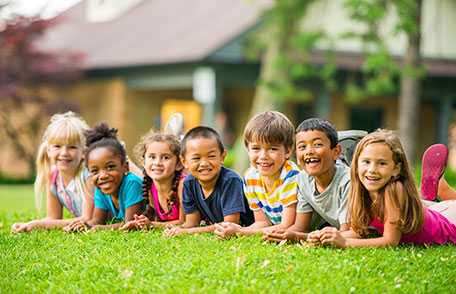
[{"xmin": 87, "ymin": 147, "xmax": 128, "ymax": 197}]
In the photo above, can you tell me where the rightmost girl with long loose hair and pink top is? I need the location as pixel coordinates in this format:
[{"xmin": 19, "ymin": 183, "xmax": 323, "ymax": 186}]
[{"xmin": 308, "ymin": 130, "xmax": 456, "ymax": 248}]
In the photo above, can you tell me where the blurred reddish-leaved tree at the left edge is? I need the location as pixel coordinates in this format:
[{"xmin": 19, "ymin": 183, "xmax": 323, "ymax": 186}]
[{"xmin": 0, "ymin": 10, "xmax": 82, "ymax": 175}]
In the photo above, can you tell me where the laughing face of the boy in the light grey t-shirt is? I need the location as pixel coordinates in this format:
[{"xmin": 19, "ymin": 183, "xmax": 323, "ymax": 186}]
[{"xmin": 296, "ymin": 130, "xmax": 341, "ymax": 177}]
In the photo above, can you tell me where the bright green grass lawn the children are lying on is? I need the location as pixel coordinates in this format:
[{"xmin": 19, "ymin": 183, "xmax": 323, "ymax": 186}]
[{"xmin": 0, "ymin": 186, "xmax": 456, "ymax": 293}]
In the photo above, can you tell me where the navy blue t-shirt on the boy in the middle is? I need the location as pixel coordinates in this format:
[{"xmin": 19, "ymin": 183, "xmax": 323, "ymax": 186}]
[{"xmin": 182, "ymin": 166, "xmax": 253, "ymax": 225}]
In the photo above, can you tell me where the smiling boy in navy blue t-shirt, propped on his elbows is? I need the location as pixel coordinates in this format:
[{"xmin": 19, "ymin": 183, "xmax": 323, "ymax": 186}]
[{"xmin": 165, "ymin": 126, "xmax": 253, "ymax": 237}]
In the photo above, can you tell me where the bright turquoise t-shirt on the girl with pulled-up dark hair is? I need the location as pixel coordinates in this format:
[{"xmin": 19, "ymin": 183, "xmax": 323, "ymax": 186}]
[{"xmin": 94, "ymin": 172, "xmax": 143, "ymax": 221}]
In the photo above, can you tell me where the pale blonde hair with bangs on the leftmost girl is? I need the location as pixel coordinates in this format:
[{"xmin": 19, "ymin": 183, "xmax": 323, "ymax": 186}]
[{"xmin": 34, "ymin": 111, "xmax": 89, "ymax": 210}]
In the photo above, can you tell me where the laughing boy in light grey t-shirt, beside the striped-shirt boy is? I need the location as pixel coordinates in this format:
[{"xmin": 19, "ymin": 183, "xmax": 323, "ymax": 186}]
[{"xmin": 265, "ymin": 118, "xmax": 350, "ymax": 242}]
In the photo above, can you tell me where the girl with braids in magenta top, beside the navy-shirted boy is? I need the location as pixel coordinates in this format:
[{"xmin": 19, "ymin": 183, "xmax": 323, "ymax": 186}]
[{"xmin": 123, "ymin": 131, "xmax": 185, "ymax": 230}]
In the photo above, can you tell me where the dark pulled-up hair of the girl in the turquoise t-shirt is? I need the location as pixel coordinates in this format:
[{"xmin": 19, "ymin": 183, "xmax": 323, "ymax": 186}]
[{"xmin": 85, "ymin": 123, "xmax": 127, "ymax": 164}]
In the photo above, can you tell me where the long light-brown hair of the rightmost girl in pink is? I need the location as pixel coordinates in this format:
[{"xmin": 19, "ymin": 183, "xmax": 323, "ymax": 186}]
[{"xmin": 348, "ymin": 129, "xmax": 424, "ymax": 237}]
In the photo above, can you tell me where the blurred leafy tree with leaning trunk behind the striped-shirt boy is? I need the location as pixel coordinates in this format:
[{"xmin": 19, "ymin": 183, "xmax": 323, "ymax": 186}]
[{"xmin": 234, "ymin": 0, "xmax": 321, "ymax": 172}]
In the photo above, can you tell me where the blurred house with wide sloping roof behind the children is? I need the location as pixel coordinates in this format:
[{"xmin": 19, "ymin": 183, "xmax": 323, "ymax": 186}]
[{"xmin": 0, "ymin": 0, "xmax": 456, "ymax": 177}]
